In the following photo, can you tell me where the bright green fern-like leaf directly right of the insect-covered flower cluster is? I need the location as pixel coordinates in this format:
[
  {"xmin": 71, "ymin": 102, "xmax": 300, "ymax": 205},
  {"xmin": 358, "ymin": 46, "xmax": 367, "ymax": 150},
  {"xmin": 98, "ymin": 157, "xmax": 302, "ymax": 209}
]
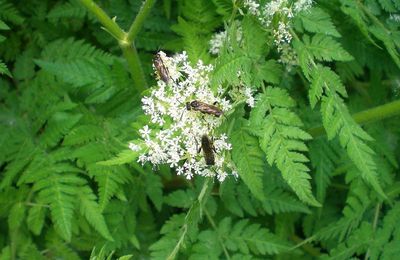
[{"xmin": 250, "ymin": 88, "xmax": 319, "ymax": 206}]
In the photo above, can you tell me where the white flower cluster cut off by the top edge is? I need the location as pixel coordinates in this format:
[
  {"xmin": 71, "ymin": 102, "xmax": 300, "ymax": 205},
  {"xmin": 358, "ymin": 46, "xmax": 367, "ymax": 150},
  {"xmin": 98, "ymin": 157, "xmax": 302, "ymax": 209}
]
[{"xmin": 244, "ymin": 0, "xmax": 313, "ymax": 68}]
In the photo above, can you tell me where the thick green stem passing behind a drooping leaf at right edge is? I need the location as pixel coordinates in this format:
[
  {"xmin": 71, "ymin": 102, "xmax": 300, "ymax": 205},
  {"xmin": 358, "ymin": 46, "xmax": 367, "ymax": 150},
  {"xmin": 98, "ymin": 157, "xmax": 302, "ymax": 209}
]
[{"xmin": 307, "ymin": 100, "xmax": 400, "ymax": 137}]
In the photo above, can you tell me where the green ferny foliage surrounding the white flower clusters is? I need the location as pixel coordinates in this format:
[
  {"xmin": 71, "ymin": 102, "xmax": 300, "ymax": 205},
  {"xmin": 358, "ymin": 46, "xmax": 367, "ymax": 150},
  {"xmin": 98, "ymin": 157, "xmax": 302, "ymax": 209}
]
[{"xmin": 0, "ymin": 0, "xmax": 400, "ymax": 259}]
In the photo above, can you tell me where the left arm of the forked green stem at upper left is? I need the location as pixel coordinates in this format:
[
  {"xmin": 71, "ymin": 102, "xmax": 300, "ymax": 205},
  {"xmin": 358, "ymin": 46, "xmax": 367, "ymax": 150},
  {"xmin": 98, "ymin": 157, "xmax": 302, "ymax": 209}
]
[{"xmin": 80, "ymin": 0, "xmax": 125, "ymax": 41}]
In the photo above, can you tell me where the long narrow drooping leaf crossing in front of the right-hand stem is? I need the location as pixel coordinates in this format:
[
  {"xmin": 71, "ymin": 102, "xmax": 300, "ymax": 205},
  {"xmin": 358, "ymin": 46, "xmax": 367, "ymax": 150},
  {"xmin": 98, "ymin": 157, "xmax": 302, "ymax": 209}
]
[{"xmin": 295, "ymin": 32, "xmax": 385, "ymax": 197}]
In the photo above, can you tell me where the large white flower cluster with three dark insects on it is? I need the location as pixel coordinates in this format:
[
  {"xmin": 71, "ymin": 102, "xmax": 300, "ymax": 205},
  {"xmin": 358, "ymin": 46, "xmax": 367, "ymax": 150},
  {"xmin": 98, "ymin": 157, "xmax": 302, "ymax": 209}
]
[{"xmin": 136, "ymin": 52, "xmax": 237, "ymax": 181}]
